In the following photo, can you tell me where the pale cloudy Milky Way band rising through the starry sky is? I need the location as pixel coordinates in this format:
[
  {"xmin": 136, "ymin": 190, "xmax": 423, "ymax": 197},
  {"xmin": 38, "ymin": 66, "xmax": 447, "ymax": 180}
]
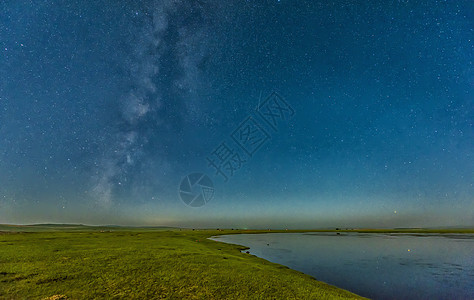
[{"xmin": 94, "ymin": 1, "xmax": 216, "ymax": 205}]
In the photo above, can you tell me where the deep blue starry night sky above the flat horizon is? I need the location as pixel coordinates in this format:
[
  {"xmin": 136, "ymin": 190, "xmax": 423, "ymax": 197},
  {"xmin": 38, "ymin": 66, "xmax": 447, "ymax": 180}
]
[{"xmin": 0, "ymin": 0, "xmax": 474, "ymax": 228}]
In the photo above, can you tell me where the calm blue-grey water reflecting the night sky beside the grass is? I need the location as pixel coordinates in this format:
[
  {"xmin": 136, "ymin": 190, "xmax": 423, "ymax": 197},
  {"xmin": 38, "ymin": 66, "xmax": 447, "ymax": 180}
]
[{"xmin": 213, "ymin": 233, "xmax": 474, "ymax": 299}]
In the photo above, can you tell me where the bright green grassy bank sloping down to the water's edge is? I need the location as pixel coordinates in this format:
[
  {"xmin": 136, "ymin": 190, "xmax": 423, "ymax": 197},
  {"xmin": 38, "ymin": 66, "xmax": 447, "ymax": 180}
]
[{"xmin": 0, "ymin": 229, "xmax": 360, "ymax": 299}]
